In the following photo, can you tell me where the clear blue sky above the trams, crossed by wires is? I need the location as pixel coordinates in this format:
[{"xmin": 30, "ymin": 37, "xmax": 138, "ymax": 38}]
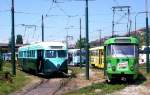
[{"xmin": 0, "ymin": 0, "xmax": 150, "ymax": 43}]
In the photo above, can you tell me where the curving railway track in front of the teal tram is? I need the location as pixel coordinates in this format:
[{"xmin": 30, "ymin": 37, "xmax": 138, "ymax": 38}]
[{"xmin": 10, "ymin": 68, "xmax": 72, "ymax": 95}]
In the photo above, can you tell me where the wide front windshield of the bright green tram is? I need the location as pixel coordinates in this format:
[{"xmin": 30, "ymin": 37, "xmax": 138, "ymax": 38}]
[{"xmin": 109, "ymin": 45, "xmax": 138, "ymax": 57}]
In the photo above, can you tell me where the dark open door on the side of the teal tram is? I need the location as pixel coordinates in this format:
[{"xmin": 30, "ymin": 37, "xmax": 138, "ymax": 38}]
[{"xmin": 37, "ymin": 50, "xmax": 44, "ymax": 73}]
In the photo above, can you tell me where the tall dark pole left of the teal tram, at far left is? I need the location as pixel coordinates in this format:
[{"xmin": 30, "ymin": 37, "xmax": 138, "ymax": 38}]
[{"xmin": 11, "ymin": 0, "xmax": 16, "ymax": 75}]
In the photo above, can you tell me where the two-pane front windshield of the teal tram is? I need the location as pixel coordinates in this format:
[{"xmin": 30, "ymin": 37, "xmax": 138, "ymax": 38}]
[{"xmin": 45, "ymin": 50, "xmax": 67, "ymax": 58}]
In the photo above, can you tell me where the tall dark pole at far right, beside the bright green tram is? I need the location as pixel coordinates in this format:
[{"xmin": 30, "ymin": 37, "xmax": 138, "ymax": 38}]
[{"xmin": 145, "ymin": 0, "xmax": 150, "ymax": 73}]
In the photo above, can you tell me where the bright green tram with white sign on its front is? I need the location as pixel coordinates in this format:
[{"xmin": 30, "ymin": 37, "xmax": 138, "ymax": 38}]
[{"xmin": 104, "ymin": 37, "xmax": 139, "ymax": 81}]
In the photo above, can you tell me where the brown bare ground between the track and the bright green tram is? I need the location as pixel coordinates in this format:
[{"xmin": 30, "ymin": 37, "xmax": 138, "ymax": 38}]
[{"xmin": 56, "ymin": 70, "xmax": 105, "ymax": 95}]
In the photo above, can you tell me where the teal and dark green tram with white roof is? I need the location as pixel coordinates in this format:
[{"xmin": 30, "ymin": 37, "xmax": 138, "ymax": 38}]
[{"xmin": 18, "ymin": 42, "xmax": 68, "ymax": 75}]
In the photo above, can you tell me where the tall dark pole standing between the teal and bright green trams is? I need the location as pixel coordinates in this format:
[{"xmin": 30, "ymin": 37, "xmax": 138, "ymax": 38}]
[{"xmin": 85, "ymin": 0, "xmax": 89, "ymax": 80}]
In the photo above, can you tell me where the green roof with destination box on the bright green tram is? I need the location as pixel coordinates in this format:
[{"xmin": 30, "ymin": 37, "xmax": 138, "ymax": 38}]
[{"xmin": 104, "ymin": 37, "xmax": 139, "ymax": 45}]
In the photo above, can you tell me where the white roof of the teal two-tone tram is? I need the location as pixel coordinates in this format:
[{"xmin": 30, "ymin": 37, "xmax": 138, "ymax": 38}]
[{"xmin": 19, "ymin": 42, "xmax": 67, "ymax": 51}]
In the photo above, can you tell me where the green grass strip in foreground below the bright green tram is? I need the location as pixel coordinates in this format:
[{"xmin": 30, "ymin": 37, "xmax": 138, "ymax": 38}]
[{"xmin": 64, "ymin": 82, "xmax": 127, "ymax": 95}]
